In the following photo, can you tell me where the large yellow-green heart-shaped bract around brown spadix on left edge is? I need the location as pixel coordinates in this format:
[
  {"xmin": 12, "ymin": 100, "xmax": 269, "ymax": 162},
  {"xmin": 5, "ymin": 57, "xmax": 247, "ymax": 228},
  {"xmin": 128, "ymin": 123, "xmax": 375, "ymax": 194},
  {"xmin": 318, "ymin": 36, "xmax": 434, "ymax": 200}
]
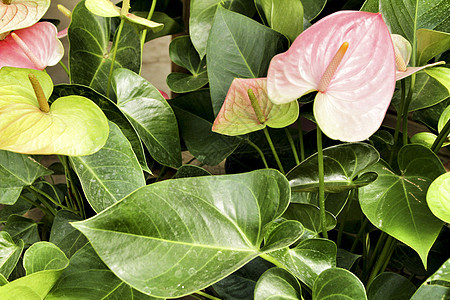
[{"xmin": 0, "ymin": 67, "xmax": 109, "ymax": 156}]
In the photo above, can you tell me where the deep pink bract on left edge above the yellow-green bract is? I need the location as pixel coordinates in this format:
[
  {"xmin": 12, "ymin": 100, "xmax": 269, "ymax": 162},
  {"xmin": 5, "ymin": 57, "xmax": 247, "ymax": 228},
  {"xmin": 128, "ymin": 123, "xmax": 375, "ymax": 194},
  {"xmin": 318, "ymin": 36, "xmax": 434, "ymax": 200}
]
[{"xmin": 0, "ymin": 22, "xmax": 64, "ymax": 70}]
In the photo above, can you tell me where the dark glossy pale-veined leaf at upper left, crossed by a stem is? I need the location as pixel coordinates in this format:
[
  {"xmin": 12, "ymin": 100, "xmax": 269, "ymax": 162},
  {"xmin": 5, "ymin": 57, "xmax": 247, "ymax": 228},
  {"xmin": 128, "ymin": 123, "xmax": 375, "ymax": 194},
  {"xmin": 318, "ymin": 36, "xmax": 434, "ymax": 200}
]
[{"xmin": 68, "ymin": 1, "xmax": 141, "ymax": 94}]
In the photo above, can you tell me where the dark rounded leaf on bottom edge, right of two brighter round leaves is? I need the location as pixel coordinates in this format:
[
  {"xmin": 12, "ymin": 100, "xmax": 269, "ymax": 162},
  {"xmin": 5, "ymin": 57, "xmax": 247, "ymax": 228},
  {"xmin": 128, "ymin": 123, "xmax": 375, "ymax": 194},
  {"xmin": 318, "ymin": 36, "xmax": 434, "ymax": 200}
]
[{"xmin": 367, "ymin": 272, "xmax": 416, "ymax": 300}]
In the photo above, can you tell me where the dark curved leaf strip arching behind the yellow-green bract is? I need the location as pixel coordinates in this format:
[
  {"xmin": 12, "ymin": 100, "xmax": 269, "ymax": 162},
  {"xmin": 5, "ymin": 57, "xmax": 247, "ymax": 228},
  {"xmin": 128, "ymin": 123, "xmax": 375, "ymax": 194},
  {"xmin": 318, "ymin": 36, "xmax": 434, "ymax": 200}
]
[{"xmin": 52, "ymin": 84, "xmax": 151, "ymax": 174}]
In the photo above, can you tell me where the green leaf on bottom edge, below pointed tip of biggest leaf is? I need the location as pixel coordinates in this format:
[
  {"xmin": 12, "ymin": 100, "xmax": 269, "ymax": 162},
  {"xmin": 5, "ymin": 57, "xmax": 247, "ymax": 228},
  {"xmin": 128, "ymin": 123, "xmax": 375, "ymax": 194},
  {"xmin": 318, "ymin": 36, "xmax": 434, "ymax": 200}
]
[{"xmin": 45, "ymin": 244, "xmax": 155, "ymax": 300}]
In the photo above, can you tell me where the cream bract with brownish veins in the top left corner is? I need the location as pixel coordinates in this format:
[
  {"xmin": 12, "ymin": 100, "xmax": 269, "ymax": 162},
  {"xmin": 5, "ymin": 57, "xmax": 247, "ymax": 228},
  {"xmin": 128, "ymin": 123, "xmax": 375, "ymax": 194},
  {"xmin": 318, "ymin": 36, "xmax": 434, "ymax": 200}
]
[{"xmin": 0, "ymin": 0, "xmax": 50, "ymax": 36}]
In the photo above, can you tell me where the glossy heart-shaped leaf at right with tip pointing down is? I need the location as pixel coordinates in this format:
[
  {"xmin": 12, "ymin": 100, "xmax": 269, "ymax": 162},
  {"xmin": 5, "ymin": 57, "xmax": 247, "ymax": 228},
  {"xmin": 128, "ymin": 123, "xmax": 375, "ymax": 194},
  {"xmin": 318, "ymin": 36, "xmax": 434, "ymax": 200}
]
[{"xmin": 359, "ymin": 144, "xmax": 445, "ymax": 266}]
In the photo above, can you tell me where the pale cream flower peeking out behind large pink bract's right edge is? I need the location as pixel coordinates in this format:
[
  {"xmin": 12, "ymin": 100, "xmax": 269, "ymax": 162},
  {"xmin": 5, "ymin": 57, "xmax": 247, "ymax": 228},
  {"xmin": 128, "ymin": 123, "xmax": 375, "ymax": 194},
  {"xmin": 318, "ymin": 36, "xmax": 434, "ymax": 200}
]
[{"xmin": 392, "ymin": 34, "xmax": 445, "ymax": 80}]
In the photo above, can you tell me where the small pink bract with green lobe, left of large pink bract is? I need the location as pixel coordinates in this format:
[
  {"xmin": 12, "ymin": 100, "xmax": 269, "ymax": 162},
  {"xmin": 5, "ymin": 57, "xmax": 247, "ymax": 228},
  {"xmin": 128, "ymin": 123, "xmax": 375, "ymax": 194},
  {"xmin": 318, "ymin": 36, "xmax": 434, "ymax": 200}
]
[{"xmin": 212, "ymin": 78, "xmax": 298, "ymax": 136}]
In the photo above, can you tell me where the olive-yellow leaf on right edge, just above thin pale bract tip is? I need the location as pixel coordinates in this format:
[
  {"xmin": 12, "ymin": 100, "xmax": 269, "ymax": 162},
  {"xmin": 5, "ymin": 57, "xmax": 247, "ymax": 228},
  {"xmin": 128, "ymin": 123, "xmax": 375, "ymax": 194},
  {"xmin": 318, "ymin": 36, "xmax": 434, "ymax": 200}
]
[{"xmin": 417, "ymin": 29, "xmax": 450, "ymax": 66}]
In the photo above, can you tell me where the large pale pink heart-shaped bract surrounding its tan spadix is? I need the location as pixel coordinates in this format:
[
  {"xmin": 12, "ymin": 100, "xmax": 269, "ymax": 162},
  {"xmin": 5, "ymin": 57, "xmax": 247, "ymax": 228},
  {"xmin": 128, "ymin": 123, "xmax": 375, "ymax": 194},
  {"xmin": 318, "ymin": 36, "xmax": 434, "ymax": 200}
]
[{"xmin": 267, "ymin": 11, "xmax": 395, "ymax": 142}]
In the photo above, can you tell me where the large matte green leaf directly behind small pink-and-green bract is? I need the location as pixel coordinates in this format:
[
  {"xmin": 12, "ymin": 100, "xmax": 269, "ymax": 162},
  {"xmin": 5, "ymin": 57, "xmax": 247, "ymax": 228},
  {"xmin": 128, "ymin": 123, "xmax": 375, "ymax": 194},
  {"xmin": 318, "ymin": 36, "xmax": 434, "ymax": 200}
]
[{"xmin": 206, "ymin": 7, "xmax": 287, "ymax": 115}]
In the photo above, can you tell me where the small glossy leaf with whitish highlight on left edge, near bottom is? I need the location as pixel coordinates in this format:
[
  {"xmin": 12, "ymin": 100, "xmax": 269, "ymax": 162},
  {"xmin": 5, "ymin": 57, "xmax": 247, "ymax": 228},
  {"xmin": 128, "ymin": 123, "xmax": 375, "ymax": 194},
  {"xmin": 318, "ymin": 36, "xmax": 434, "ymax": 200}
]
[{"xmin": 0, "ymin": 231, "xmax": 24, "ymax": 278}]
